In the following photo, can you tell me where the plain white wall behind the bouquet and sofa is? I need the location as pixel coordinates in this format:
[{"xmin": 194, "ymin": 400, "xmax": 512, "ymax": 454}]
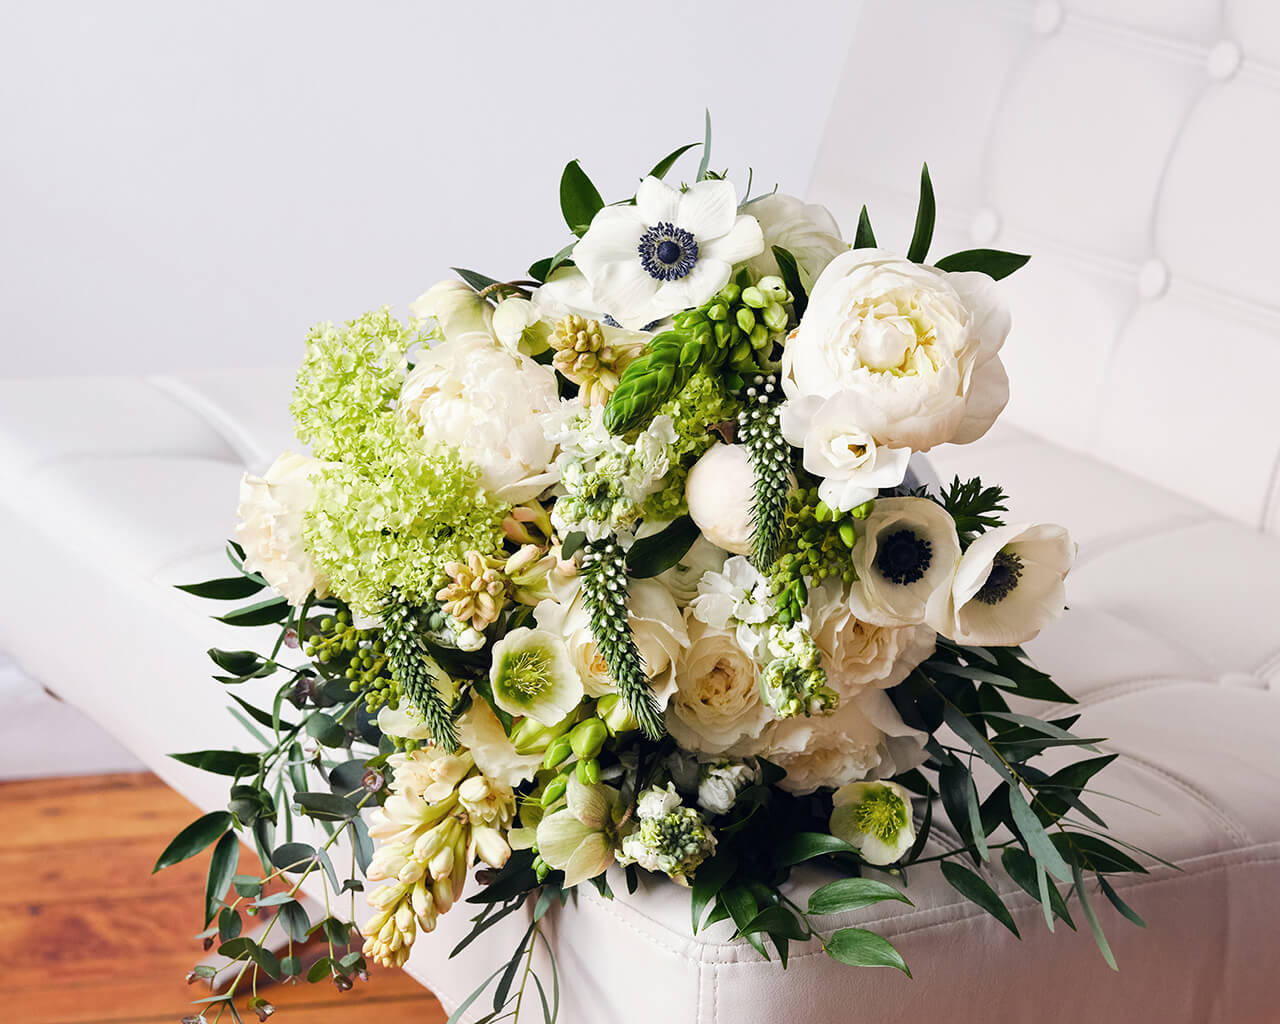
[{"xmin": 0, "ymin": 0, "xmax": 856, "ymax": 376}]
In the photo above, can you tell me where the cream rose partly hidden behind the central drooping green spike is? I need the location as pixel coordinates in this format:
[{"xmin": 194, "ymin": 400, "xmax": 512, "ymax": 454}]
[{"xmin": 534, "ymin": 579, "xmax": 689, "ymax": 708}]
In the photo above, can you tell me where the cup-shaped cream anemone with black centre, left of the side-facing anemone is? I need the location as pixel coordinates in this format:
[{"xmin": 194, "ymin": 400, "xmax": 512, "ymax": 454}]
[{"xmin": 849, "ymin": 498, "xmax": 960, "ymax": 628}]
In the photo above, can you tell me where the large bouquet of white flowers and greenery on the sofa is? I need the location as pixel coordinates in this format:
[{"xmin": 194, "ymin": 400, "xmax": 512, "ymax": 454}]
[{"xmin": 157, "ymin": 123, "xmax": 1162, "ymax": 1020}]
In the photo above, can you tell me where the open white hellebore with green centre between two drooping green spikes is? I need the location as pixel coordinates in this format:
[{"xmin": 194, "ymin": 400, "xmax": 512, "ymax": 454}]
[{"xmin": 489, "ymin": 626, "xmax": 584, "ymax": 726}]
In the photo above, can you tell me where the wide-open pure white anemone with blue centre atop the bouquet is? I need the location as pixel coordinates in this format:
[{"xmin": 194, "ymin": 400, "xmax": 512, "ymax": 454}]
[{"xmin": 573, "ymin": 177, "xmax": 764, "ymax": 329}]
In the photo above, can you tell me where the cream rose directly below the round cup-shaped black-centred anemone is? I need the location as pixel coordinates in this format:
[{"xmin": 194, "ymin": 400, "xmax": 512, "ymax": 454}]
[{"xmin": 809, "ymin": 582, "xmax": 937, "ymax": 698}]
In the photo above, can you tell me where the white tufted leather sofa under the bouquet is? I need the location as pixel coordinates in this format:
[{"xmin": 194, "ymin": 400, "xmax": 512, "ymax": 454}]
[{"xmin": 0, "ymin": 0, "xmax": 1280, "ymax": 1024}]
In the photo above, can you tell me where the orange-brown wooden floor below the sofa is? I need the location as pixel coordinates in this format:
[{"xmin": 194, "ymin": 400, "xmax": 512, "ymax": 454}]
[{"xmin": 0, "ymin": 774, "xmax": 445, "ymax": 1024}]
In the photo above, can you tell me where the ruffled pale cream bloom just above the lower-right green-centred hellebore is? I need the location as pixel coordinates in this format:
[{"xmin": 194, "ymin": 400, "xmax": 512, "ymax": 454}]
[{"xmin": 731, "ymin": 689, "xmax": 929, "ymax": 795}]
